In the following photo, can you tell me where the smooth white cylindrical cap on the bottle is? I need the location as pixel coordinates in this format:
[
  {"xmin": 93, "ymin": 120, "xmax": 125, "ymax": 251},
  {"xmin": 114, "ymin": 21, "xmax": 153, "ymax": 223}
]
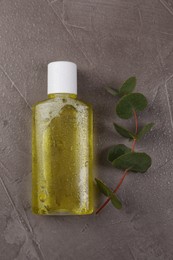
[{"xmin": 48, "ymin": 61, "xmax": 77, "ymax": 94}]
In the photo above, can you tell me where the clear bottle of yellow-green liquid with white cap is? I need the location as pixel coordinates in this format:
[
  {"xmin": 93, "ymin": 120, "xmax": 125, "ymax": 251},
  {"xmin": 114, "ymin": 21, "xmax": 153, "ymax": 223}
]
[{"xmin": 32, "ymin": 62, "xmax": 94, "ymax": 215}]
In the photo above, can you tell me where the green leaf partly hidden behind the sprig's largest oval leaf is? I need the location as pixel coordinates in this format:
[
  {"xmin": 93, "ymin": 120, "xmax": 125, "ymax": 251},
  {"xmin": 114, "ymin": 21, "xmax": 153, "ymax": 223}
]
[{"xmin": 108, "ymin": 144, "xmax": 131, "ymax": 162}]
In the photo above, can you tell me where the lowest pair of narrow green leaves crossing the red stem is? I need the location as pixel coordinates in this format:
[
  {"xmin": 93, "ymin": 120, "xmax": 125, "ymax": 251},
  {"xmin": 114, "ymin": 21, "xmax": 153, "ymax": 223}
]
[{"xmin": 95, "ymin": 178, "xmax": 122, "ymax": 209}]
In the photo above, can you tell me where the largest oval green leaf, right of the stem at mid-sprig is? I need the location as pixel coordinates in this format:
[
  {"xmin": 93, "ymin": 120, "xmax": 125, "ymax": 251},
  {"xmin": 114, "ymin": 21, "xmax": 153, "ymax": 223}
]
[{"xmin": 112, "ymin": 152, "xmax": 151, "ymax": 173}]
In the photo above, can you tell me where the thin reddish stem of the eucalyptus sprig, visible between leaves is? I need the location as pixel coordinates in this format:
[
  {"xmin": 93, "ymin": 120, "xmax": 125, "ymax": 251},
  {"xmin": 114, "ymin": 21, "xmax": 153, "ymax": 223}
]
[{"xmin": 96, "ymin": 110, "xmax": 138, "ymax": 214}]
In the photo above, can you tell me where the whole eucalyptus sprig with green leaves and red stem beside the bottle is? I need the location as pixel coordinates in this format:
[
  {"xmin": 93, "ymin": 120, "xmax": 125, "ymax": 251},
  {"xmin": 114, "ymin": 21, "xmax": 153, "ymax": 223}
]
[{"xmin": 96, "ymin": 77, "xmax": 154, "ymax": 214}]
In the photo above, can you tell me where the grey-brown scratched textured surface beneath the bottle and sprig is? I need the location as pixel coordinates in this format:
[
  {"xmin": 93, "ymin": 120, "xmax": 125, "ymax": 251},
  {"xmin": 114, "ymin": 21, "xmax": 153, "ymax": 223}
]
[{"xmin": 0, "ymin": 0, "xmax": 173, "ymax": 260}]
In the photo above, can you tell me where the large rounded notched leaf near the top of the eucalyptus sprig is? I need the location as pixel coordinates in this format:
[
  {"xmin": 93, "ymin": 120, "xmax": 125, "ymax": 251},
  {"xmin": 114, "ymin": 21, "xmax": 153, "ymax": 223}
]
[{"xmin": 116, "ymin": 93, "xmax": 147, "ymax": 119}]
